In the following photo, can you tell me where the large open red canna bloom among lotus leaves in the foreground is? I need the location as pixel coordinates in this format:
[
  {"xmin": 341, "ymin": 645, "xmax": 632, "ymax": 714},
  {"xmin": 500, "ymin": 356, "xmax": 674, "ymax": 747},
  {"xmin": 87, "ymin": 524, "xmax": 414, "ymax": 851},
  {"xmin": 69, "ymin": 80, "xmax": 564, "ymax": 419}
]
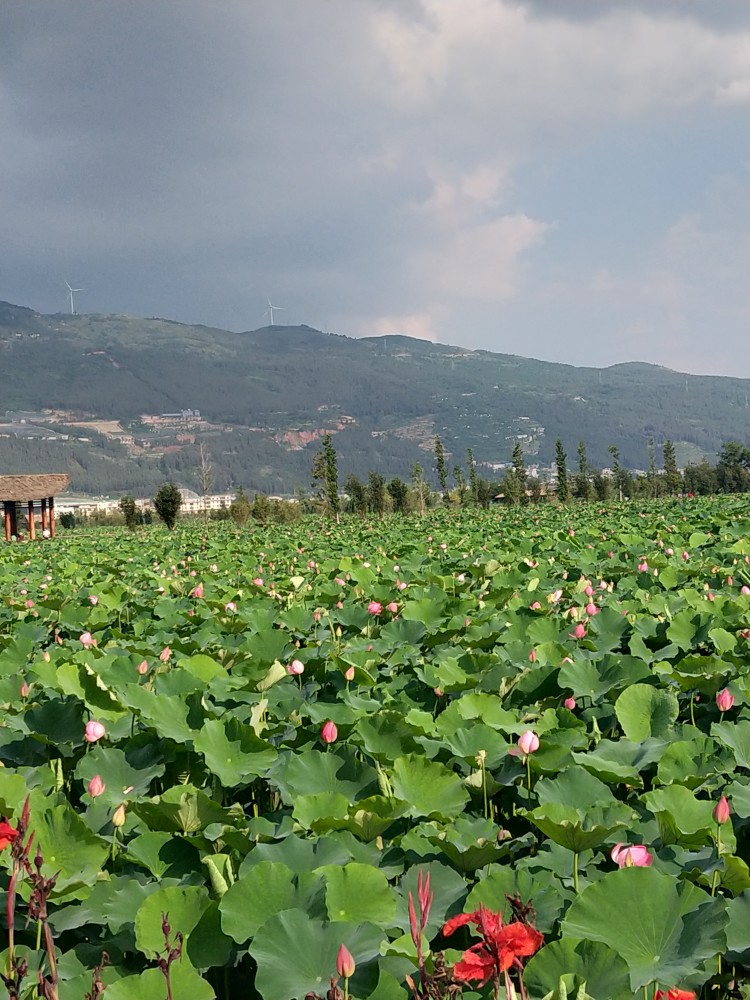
[{"xmin": 443, "ymin": 906, "xmax": 544, "ymax": 983}]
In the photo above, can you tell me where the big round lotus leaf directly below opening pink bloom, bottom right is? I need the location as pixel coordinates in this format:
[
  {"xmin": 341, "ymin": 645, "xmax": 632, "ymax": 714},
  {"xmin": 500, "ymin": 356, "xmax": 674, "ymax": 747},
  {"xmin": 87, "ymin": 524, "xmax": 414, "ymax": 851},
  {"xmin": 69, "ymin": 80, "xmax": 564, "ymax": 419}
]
[{"xmin": 562, "ymin": 868, "xmax": 728, "ymax": 991}]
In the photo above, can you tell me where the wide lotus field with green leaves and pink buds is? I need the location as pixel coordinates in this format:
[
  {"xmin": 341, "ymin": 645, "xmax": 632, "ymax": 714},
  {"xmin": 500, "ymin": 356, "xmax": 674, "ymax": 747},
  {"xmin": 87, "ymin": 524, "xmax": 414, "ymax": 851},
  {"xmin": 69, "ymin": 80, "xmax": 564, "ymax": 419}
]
[{"xmin": 0, "ymin": 497, "xmax": 750, "ymax": 1000}]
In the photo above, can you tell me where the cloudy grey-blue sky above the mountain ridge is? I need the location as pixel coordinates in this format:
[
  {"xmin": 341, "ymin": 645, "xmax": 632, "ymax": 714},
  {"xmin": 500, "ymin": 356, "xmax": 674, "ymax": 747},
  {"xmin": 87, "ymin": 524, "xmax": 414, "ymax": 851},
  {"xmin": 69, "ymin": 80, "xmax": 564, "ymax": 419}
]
[{"xmin": 0, "ymin": 0, "xmax": 750, "ymax": 377}]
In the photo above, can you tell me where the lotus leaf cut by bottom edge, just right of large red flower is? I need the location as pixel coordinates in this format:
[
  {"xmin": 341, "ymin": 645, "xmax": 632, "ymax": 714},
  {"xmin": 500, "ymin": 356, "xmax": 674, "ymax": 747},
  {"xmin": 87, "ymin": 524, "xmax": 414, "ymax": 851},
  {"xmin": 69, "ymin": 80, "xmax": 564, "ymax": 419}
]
[{"xmin": 523, "ymin": 938, "xmax": 633, "ymax": 1000}]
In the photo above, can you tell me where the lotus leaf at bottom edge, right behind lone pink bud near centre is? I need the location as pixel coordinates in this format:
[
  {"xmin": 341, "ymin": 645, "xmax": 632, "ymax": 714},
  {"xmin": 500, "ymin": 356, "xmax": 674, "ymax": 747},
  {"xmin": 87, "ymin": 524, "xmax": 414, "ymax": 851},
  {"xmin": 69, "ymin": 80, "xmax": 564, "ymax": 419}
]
[{"xmin": 249, "ymin": 910, "xmax": 385, "ymax": 1000}]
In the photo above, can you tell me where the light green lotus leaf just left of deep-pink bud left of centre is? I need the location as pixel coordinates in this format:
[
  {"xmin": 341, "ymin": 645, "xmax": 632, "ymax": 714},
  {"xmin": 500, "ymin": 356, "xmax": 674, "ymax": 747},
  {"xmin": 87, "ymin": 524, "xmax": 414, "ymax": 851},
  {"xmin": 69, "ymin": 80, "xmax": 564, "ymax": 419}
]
[{"xmin": 194, "ymin": 718, "xmax": 277, "ymax": 788}]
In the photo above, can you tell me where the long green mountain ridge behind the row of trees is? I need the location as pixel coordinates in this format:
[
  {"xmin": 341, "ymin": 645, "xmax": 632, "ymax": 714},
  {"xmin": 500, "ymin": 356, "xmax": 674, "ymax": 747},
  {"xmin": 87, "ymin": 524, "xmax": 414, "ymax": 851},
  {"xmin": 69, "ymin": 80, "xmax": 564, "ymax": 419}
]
[{"xmin": 0, "ymin": 302, "xmax": 750, "ymax": 494}]
